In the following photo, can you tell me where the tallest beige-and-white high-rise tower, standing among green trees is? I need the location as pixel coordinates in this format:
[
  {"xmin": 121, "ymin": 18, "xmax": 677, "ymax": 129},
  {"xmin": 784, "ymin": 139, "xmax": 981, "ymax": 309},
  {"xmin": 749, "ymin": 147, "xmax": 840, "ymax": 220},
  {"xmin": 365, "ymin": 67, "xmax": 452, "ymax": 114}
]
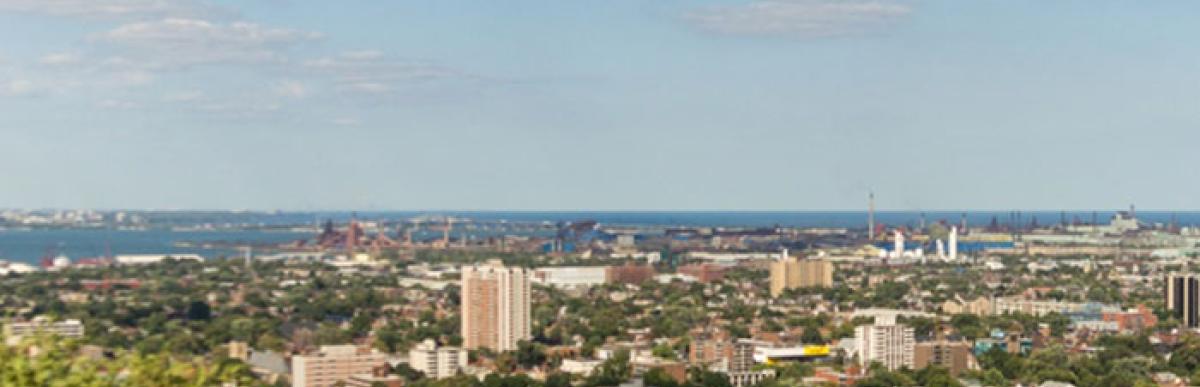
[{"xmin": 462, "ymin": 260, "xmax": 533, "ymax": 351}]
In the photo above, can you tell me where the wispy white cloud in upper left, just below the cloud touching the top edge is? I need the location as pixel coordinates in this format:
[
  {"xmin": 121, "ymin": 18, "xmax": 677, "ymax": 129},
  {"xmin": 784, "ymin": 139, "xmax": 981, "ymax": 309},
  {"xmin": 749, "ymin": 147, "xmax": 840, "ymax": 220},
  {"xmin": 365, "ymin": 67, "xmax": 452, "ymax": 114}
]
[{"xmin": 100, "ymin": 18, "xmax": 320, "ymax": 66}]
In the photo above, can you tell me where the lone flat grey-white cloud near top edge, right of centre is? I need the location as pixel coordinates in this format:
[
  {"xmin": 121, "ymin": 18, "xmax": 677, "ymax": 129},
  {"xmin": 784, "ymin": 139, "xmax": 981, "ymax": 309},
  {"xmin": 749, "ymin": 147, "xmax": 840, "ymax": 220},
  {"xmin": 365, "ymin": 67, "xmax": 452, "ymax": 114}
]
[{"xmin": 684, "ymin": 0, "xmax": 912, "ymax": 37}]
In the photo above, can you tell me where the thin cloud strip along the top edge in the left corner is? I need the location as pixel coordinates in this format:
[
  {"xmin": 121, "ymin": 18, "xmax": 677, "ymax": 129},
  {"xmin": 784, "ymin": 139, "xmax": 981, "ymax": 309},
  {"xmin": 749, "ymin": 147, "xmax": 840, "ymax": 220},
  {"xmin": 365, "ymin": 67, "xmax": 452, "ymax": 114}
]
[{"xmin": 0, "ymin": 0, "xmax": 223, "ymax": 18}]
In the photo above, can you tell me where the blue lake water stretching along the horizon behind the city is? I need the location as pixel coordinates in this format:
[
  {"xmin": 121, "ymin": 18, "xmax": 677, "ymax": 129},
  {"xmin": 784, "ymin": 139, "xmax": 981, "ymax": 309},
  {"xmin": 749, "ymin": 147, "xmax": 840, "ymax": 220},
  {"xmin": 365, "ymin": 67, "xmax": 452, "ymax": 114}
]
[{"xmin": 0, "ymin": 212, "xmax": 1200, "ymax": 263}]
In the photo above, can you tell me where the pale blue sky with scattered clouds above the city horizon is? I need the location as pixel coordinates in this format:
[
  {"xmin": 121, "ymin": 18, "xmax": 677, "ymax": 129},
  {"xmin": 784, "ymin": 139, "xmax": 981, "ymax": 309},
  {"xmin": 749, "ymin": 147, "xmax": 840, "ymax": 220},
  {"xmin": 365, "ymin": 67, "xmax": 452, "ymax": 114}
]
[{"xmin": 0, "ymin": 0, "xmax": 1200, "ymax": 210}]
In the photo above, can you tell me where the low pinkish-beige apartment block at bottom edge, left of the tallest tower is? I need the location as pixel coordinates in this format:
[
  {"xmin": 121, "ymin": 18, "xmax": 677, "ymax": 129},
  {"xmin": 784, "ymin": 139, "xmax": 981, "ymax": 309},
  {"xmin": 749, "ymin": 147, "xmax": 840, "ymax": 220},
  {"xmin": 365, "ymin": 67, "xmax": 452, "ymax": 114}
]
[{"xmin": 292, "ymin": 345, "xmax": 388, "ymax": 387}]
